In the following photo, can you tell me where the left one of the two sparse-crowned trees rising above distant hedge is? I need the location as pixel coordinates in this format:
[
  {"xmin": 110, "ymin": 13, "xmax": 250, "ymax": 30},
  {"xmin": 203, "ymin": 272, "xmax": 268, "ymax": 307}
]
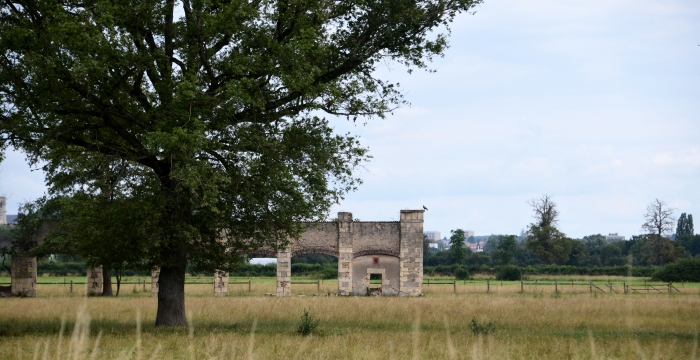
[{"xmin": 525, "ymin": 194, "xmax": 571, "ymax": 264}]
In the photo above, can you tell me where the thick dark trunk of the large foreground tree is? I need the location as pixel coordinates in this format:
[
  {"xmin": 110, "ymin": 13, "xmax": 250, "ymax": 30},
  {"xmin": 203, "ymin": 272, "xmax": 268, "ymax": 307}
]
[{"xmin": 156, "ymin": 246, "xmax": 187, "ymax": 326}]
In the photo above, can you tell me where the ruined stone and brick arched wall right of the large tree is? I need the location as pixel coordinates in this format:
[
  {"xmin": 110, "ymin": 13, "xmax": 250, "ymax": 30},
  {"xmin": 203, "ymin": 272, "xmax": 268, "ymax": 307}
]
[{"xmin": 266, "ymin": 210, "xmax": 423, "ymax": 296}]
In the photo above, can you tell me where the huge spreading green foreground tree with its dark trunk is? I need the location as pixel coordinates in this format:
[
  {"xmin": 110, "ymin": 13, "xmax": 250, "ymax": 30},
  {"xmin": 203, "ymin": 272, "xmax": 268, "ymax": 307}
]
[{"xmin": 0, "ymin": 0, "xmax": 480, "ymax": 326}]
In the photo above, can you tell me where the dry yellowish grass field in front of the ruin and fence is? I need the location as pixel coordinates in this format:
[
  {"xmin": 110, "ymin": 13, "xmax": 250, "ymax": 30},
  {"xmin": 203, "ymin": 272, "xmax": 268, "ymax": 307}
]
[{"xmin": 0, "ymin": 278, "xmax": 700, "ymax": 359}]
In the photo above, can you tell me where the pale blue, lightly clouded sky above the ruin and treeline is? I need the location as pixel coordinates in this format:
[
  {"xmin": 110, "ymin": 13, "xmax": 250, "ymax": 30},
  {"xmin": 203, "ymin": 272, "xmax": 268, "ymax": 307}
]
[{"xmin": 0, "ymin": 0, "xmax": 700, "ymax": 238}]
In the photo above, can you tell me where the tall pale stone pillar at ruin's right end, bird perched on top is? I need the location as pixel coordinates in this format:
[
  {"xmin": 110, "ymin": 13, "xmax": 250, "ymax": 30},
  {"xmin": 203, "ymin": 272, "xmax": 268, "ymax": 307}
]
[{"xmin": 399, "ymin": 210, "xmax": 423, "ymax": 296}]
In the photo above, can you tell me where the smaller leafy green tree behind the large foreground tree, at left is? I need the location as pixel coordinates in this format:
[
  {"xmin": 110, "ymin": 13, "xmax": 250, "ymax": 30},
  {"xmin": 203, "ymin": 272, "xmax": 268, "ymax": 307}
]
[{"xmin": 33, "ymin": 153, "xmax": 162, "ymax": 296}]
